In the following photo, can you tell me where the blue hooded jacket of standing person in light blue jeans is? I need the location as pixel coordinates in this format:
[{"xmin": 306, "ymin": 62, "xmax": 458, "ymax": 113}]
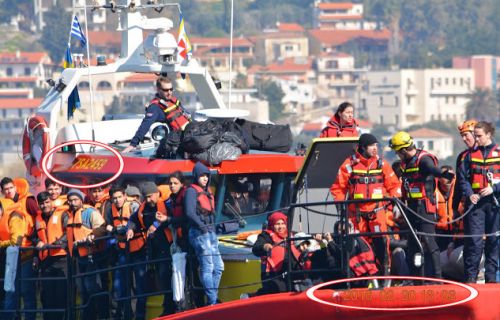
[{"xmin": 184, "ymin": 162, "xmax": 215, "ymax": 233}]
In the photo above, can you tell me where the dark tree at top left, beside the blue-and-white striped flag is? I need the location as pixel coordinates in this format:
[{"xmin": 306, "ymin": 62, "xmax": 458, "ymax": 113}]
[{"xmin": 40, "ymin": 5, "xmax": 71, "ymax": 64}]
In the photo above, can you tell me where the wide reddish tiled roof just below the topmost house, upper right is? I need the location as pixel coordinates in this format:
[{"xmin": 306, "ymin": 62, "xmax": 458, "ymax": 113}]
[{"xmin": 309, "ymin": 29, "xmax": 391, "ymax": 45}]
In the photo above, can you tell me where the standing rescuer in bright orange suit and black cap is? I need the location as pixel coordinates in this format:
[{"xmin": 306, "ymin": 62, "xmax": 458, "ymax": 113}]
[{"xmin": 330, "ymin": 133, "xmax": 401, "ymax": 274}]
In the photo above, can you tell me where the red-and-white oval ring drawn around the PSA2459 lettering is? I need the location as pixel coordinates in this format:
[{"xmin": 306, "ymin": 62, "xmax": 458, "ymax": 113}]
[{"xmin": 42, "ymin": 140, "xmax": 124, "ymax": 189}]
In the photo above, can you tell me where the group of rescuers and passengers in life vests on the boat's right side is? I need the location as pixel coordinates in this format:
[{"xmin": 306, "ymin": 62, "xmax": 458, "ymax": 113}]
[{"xmin": 251, "ymin": 102, "xmax": 500, "ymax": 295}]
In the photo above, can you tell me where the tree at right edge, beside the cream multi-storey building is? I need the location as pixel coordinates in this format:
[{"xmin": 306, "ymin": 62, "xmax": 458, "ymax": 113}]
[{"xmin": 466, "ymin": 89, "xmax": 498, "ymax": 121}]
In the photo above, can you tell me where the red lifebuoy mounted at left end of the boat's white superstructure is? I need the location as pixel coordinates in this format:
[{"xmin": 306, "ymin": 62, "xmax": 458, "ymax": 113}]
[{"xmin": 23, "ymin": 116, "xmax": 50, "ymax": 177}]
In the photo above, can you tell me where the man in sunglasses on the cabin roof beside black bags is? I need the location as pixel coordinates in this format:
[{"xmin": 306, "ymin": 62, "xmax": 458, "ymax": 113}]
[{"xmin": 122, "ymin": 76, "xmax": 190, "ymax": 153}]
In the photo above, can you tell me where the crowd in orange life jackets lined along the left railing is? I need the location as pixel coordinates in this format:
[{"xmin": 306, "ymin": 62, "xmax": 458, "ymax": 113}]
[{"xmin": 0, "ymin": 162, "xmax": 224, "ymax": 319}]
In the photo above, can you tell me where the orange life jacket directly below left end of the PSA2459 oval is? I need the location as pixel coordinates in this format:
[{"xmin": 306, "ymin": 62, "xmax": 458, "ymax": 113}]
[{"xmin": 36, "ymin": 207, "xmax": 68, "ymax": 260}]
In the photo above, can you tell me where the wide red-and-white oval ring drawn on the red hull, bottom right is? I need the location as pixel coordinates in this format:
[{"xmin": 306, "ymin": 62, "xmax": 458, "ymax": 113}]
[{"xmin": 306, "ymin": 276, "xmax": 478, "ymax": 311}]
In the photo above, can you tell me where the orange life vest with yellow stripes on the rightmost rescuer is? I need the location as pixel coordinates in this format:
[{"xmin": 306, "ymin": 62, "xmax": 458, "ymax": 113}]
[{"xmin": 469, "ymin": 145, "xmax": 500, "ymax": 192}]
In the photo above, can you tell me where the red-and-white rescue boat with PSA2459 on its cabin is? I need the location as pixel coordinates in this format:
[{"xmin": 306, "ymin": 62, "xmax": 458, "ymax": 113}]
[{"xmin": 23, "ymin": 0, "xmax": 500, "ymax": 319}]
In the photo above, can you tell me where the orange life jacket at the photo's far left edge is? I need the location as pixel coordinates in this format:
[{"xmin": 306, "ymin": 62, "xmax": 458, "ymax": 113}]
[{"xmin": 0, "ymin": 199, "xmax": 33, "ymax": 248}]
